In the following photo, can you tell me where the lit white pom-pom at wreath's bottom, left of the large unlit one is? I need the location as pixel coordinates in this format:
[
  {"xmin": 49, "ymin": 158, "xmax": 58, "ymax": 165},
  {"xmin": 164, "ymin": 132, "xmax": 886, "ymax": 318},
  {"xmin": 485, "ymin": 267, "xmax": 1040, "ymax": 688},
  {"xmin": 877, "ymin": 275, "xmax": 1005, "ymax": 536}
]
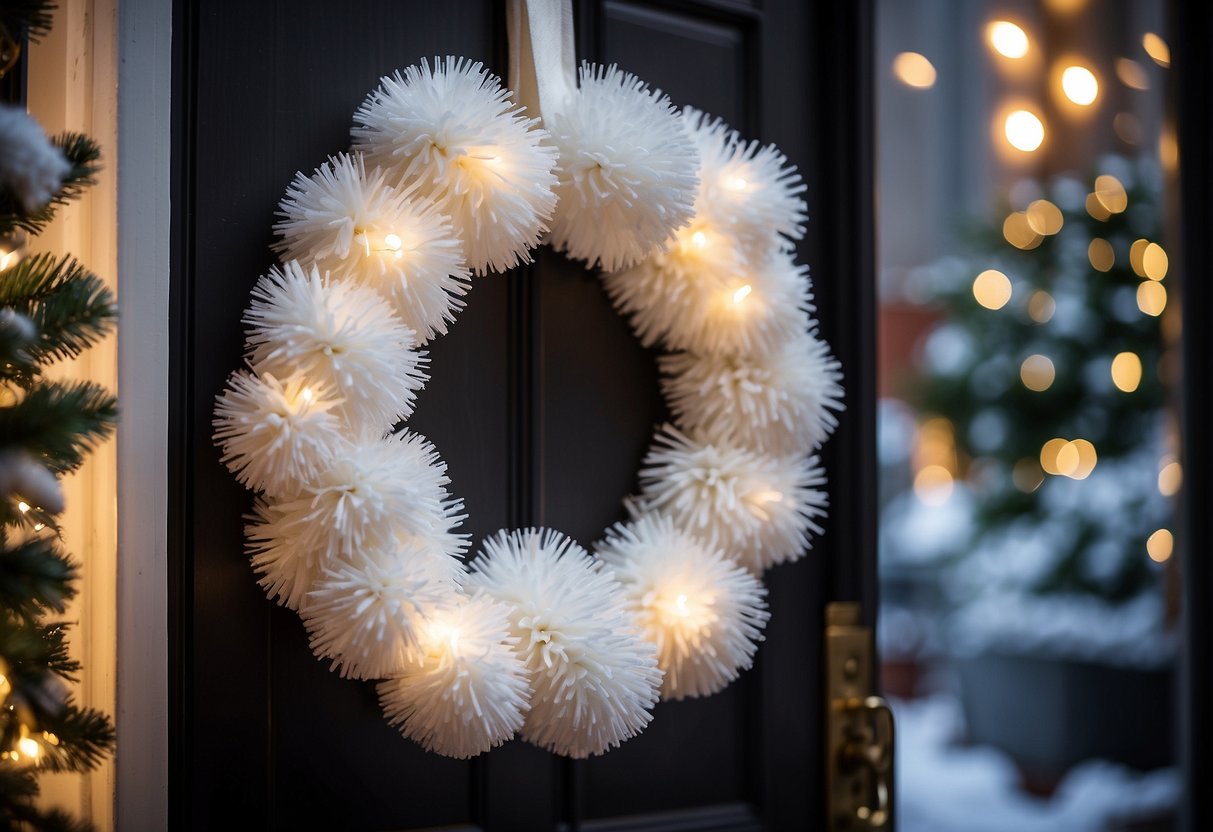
[{"xmin": 377, "ymin": 595, "xmax": 530, "ymax": 759}]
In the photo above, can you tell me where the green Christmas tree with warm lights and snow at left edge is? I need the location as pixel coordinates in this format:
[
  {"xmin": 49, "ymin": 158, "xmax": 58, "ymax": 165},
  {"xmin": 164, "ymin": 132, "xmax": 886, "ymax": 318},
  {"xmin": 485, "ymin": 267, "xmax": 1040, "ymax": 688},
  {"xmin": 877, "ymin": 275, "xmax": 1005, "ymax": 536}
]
[{"xmin": 0, "ymin": 2, "xmax": 116, "ymax": 830}]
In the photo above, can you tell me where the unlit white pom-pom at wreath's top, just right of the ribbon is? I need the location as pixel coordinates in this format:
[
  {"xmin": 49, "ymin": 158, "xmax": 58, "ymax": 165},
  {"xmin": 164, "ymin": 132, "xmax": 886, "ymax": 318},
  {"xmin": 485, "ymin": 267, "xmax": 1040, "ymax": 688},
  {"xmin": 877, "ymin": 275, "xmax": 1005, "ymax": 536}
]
[{"xmin": 543, "ymin": 64, "xmax": 699, "ymax": 272}]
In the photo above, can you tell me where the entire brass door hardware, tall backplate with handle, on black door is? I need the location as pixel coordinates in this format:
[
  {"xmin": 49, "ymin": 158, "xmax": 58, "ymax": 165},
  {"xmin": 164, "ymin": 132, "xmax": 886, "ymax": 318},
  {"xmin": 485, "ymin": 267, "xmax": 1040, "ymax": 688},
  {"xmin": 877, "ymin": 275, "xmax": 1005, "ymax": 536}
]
[{"xmin": 825, "ymin": 603, "xmax": 895, "ymax": 832}]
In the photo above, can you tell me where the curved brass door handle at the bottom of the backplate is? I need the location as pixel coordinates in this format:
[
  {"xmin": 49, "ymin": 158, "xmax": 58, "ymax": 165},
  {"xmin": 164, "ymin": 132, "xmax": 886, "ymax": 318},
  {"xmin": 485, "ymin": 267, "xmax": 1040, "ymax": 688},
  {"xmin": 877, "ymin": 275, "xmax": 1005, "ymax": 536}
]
[{"xmin": 838, "ymin": 696, "xmax": 894, "ymax": 830}]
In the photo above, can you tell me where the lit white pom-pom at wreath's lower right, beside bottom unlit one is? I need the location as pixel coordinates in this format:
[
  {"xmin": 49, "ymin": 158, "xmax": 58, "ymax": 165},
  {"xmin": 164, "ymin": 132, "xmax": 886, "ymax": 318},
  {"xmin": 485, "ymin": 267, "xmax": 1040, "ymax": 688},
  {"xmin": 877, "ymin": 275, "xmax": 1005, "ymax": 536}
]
[{"xmin": 594, "ymin": 514, "xmax": 770, "ymax": 700}]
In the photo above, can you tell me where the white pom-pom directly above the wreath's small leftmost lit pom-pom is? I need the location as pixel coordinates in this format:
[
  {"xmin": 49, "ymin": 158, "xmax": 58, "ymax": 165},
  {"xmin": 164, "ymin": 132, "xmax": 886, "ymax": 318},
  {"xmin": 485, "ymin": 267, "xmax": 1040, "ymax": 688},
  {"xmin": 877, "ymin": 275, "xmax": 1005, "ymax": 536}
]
[{"xmin": 244, "ymin": 261, "xmax": 426, "ymax": 433}]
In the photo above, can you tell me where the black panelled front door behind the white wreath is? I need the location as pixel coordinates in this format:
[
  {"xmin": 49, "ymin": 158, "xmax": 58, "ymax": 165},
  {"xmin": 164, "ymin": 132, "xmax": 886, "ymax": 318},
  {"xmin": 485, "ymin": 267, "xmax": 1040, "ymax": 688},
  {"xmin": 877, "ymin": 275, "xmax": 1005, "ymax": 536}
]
[{"xmin": 170, "ymin": 0, "xmax": 875, "ymax": 830}]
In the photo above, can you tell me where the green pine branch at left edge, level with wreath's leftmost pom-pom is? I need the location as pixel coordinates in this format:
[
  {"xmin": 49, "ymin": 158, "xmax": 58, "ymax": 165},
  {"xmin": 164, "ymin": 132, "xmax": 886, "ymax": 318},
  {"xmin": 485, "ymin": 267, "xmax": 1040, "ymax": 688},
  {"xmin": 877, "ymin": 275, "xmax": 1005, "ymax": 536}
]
[{"xmin": 0, "ymin": 381, "xmax": 118, "ymax": 474}]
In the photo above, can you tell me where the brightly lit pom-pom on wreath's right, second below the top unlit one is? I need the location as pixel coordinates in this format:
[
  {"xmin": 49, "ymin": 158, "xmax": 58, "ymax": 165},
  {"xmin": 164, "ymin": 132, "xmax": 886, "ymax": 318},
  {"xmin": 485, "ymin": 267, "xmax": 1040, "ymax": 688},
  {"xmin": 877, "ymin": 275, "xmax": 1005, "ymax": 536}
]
[{"xmin": 607, "ymin": 241, "xmax": 813, "ymax": 355}]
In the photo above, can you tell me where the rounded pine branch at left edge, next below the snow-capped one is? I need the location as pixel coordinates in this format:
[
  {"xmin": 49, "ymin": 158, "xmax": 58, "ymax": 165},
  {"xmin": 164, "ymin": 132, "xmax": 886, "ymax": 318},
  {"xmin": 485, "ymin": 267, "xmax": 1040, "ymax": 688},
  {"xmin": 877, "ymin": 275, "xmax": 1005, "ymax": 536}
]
[{"xmin": 0, "ymin": 253, "xmax": 114, "ymax": 364}]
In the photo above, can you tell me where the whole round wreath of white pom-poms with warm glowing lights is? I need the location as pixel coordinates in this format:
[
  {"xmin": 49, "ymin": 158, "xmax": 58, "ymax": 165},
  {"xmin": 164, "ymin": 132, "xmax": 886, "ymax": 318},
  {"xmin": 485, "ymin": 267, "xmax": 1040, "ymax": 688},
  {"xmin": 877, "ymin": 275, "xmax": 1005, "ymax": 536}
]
[{"xmin": 215, "ymin": 4, "xmax": 842, "ymax": 771}]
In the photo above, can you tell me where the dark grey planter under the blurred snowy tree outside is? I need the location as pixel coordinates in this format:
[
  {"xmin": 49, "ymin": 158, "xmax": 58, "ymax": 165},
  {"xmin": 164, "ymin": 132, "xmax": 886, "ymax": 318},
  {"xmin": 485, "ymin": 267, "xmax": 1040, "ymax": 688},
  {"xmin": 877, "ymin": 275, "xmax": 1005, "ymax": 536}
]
[{"xmin": 956, "ymin": 654, "xmax": 1174, "ymax": 782}]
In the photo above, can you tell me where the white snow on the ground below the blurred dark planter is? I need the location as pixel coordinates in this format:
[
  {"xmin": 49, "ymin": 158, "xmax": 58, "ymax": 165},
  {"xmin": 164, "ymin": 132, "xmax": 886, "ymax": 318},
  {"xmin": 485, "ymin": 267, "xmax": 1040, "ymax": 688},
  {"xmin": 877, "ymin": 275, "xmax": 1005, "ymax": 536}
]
[{"xmin": 893, "ymin": 695, "xmax": 1179, "ymax": 832}]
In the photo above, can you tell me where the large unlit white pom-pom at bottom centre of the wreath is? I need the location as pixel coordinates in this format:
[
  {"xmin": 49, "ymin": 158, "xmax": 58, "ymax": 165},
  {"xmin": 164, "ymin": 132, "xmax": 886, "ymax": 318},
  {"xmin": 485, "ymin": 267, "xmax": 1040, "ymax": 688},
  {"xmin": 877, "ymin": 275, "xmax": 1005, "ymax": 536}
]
[{"xmin": 467, "ymin": 529, "xmax": 661, "ymax": 758}]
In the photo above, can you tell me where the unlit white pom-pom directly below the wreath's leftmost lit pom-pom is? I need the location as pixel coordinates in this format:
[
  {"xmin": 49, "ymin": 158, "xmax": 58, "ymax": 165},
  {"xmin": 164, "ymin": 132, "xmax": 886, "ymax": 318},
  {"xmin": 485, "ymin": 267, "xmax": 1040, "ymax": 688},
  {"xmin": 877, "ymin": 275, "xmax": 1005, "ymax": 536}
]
[{"xmin": 277, "ymin": 431, "xmax": 461, "ymax": 565}]
